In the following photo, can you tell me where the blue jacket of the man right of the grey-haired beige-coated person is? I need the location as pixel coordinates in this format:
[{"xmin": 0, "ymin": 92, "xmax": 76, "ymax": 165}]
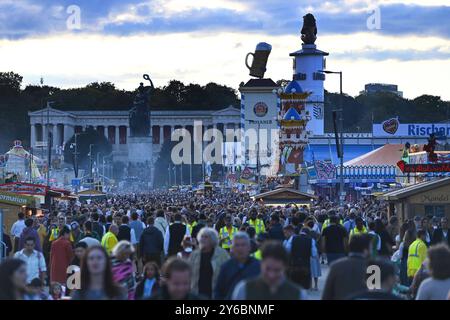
[{"xmin": 214, "ymin": 257, "xmax": 261, "ymax": 300}]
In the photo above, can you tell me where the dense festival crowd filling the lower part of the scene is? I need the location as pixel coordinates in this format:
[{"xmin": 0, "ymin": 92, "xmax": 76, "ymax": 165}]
[{"xmin": 0, "ymin": 191, "xmax": 450, "ymax": 300}]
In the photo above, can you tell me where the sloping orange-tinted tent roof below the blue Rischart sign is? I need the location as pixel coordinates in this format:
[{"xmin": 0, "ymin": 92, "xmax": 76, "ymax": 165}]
[{"xmin": 344, "ymin": 144, "xmax": 404, "ymax": 166}]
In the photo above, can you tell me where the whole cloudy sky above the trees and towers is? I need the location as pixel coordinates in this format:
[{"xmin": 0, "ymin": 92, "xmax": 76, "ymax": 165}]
[{"xmin": 0, "ymin": 0, "xmax": 450, "ymax": 100}]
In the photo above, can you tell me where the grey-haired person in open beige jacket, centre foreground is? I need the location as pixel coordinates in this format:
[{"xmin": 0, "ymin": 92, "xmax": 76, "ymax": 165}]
[{"xmin": 189, "ymin": 227, "xmax": 229, "ymax": 298}]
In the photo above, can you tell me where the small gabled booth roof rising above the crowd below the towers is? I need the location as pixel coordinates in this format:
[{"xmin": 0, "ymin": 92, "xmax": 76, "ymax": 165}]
[{"xmin": 253, "ymin": 188, "xmax": 317, "ymax": 206}]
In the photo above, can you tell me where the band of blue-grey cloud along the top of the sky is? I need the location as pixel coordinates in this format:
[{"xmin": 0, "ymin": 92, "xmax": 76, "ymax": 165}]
[{"xmin": 0, "ymin": 0, "xmax": 450, "ymax": 39}]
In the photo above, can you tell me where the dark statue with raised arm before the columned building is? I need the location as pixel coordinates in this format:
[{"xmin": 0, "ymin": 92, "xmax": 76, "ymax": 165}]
[{"xmin": 129, "ymin": 74, "xmax": 155, "ymax": 137}]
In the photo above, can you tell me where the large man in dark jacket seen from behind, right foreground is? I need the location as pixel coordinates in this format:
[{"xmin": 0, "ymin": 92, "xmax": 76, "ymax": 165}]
[{"xmin": 322, "ymin": 234, "xmax": 372, "ymax": 300}]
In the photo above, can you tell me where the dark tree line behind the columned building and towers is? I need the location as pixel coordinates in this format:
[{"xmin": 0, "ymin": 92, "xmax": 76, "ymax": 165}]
[{"xmin": 0, "ymin": 72, "xmax": 450, "ymax": 152}]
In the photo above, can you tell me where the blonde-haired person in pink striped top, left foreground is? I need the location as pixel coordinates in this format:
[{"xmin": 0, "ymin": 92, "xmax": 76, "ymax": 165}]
[{"xmin": 111, "ymin": 240, "xmax": 136, "ymax": 300}]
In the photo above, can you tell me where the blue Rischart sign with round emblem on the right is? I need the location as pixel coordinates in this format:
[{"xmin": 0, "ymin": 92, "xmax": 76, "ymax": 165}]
[{"xmin": 373, "ymin": 118, "xmax": 450, "ymax": 138}]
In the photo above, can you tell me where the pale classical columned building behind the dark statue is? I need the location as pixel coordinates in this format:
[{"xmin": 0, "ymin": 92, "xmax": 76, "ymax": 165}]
[{"xmin": 28, "ymin": 106, "xmax": 241, "ymax": 162}]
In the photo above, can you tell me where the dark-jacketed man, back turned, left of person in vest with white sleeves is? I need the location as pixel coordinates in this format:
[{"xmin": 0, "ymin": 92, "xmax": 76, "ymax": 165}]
[{"xmin": 138, "ymin": 217, "xmax": 164, "ymax": 266}]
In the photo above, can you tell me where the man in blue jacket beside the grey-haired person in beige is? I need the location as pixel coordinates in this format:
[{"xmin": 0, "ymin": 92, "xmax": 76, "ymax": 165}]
[{"xmin": 214, "ymin": 232, "xmax": 261, "ymax": 300}]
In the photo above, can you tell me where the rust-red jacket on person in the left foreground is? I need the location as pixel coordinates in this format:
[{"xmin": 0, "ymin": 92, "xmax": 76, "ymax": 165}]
[{"xmin": 50, "ymin": 238, "xmax": 73, "ymax": 285}]
